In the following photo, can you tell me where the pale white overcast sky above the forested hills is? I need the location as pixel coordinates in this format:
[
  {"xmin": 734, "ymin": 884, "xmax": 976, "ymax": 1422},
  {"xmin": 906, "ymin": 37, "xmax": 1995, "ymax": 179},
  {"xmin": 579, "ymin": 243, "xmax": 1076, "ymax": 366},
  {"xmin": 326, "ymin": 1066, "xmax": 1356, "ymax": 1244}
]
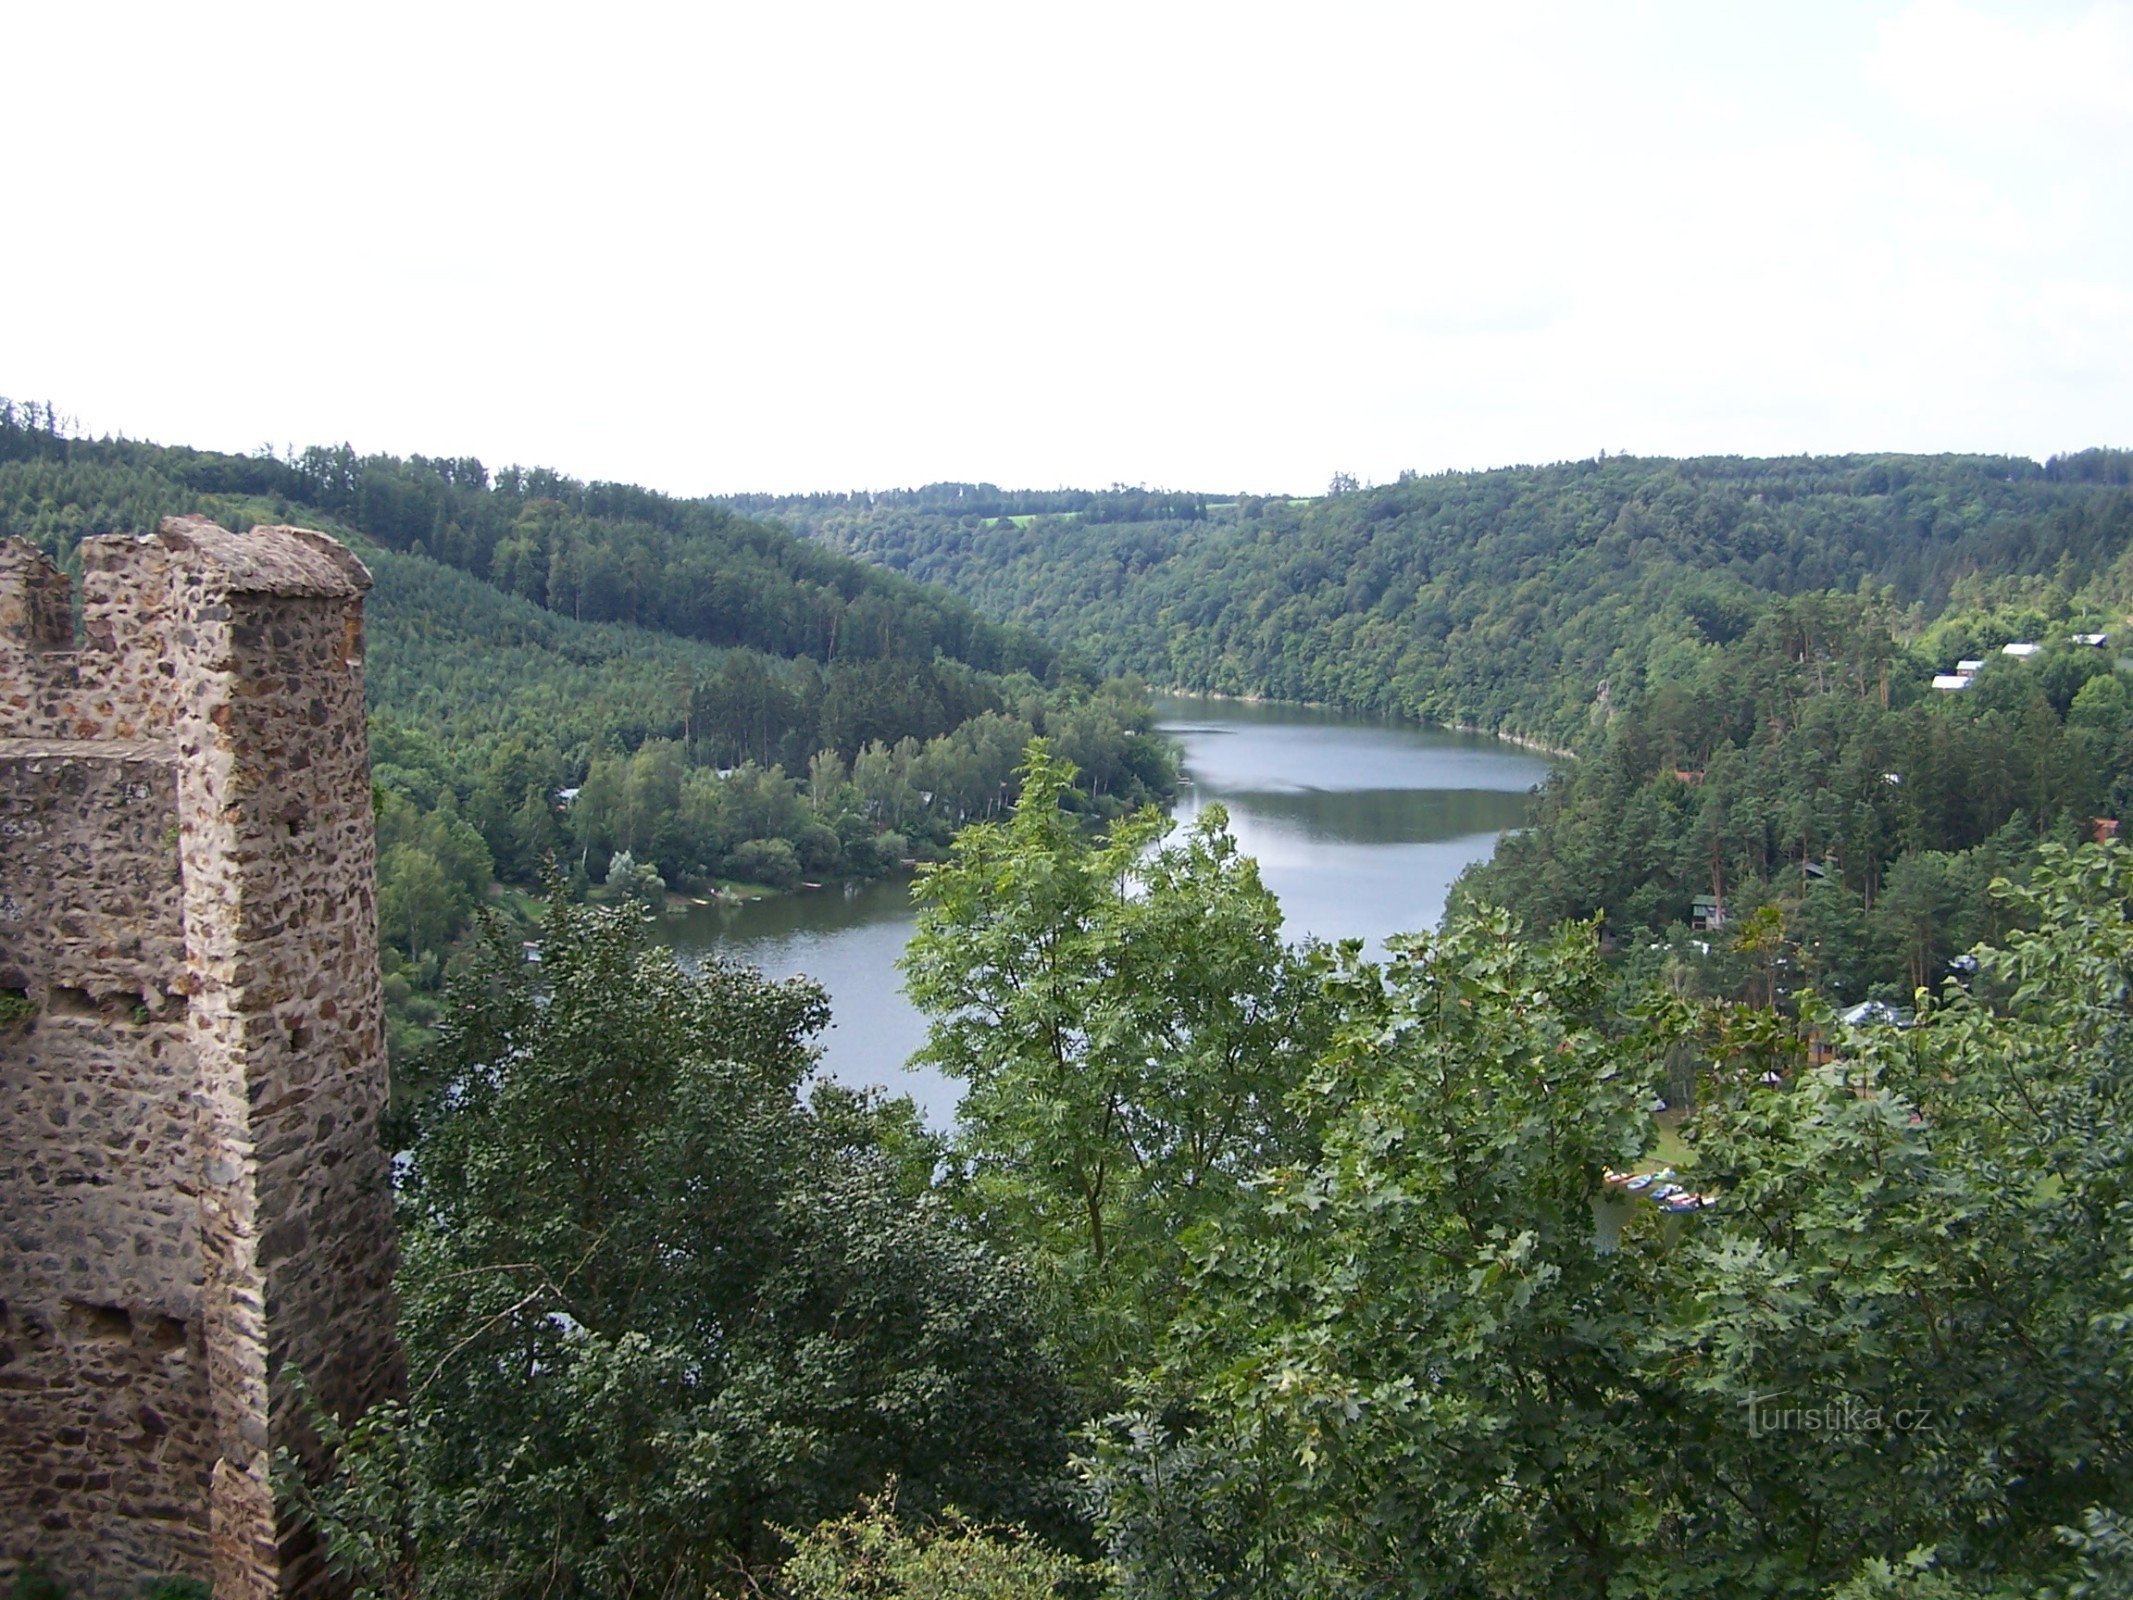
[{"xmin": 0, "ymin": 0, "xmax": 2133, "ymax": 493}]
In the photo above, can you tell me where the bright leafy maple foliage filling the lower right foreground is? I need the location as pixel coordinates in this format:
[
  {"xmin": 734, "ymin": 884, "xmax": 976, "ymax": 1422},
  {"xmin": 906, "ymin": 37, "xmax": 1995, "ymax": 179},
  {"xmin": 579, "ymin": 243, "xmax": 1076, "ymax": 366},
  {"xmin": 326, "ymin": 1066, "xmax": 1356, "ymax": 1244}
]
[{"xmin": 1094, "ymin": 866, "xmax": 2133, "ymax": 1598}]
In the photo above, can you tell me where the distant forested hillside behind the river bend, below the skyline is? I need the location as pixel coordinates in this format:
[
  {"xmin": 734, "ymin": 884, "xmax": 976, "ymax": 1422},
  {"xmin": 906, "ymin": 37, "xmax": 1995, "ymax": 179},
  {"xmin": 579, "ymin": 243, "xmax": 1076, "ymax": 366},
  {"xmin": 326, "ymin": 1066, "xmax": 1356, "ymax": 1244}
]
[{"xmin": 751, "ymin": 450, "xmax": 2133, "ymax": 745}]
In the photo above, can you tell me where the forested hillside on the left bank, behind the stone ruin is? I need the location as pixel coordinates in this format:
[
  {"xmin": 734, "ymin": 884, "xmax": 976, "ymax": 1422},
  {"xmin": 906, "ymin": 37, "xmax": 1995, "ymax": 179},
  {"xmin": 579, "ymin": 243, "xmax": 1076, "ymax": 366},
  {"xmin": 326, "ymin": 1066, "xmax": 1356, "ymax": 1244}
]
[{"xmin": 0, "ymin": 401, "xmax": 1173, "ymax": 1054}]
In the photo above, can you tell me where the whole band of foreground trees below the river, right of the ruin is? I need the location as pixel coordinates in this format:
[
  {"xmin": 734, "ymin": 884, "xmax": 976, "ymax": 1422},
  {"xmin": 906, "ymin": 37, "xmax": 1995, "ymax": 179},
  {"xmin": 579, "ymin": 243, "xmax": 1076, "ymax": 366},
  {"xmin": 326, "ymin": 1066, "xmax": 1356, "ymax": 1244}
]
[{"xmin": 301, "ymin": 785, "xmax": 2133, "ymax": 1600}]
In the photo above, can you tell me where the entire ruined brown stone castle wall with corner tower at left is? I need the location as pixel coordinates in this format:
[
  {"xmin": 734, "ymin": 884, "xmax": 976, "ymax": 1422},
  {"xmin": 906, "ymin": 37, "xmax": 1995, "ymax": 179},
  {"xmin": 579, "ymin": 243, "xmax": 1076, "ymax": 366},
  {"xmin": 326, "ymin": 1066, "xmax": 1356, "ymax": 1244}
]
[{"xmin": 0, "ymin": 518, "xmax": 399, "ymax": 1600}]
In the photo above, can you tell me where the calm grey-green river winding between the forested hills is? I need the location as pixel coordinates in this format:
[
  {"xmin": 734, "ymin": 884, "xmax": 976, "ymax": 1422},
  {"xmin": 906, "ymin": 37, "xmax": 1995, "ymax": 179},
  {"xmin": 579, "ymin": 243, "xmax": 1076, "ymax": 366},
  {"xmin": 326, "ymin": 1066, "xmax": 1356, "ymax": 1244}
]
[{"xmin": 663, "ymin": 698, "xmax": 1549, "ymax": 1129}]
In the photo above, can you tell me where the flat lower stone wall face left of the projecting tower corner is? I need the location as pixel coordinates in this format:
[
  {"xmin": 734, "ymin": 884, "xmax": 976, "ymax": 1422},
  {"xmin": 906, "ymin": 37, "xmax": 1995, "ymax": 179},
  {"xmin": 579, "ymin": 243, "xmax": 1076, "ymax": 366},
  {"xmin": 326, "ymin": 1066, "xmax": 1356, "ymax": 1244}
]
[{"xmin": 0, "ymin": 740, "xmax": 213, "ymax": 1595}]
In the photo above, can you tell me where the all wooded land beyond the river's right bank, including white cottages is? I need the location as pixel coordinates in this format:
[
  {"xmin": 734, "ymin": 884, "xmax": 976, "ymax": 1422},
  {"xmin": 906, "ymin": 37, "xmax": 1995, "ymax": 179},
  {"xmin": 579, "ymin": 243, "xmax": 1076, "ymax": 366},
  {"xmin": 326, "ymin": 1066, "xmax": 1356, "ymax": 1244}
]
[{"xmin": 751, "ymin": 448, "xmax": 2133, "ymax": 1007}]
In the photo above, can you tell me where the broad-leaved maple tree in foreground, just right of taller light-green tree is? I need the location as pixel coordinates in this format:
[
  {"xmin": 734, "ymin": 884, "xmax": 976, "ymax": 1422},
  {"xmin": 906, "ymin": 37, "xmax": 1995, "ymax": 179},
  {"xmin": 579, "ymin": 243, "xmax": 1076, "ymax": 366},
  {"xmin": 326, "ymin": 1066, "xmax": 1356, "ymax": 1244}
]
[{"xmin": 1096, "ymin": 917, "xmax": 1653, "ymax": 1596}]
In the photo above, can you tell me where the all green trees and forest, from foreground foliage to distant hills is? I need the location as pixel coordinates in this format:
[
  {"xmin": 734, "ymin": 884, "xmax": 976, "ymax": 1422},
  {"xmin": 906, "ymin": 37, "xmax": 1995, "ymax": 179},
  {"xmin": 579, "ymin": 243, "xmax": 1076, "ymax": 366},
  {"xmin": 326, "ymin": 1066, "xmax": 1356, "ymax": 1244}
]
[{"xmin": 20, "ymin": 405, "xmax": 2133, "ymax": 1600}]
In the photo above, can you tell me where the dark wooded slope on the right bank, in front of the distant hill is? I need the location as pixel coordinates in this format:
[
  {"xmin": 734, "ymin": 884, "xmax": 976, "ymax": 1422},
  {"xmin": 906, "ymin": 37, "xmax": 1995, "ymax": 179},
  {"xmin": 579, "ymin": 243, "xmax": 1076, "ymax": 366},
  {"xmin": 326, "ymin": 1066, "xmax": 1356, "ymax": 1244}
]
[{"xmin": 1461, "ymin": 595, "xmax": 2133, "ymax": 1001}]
